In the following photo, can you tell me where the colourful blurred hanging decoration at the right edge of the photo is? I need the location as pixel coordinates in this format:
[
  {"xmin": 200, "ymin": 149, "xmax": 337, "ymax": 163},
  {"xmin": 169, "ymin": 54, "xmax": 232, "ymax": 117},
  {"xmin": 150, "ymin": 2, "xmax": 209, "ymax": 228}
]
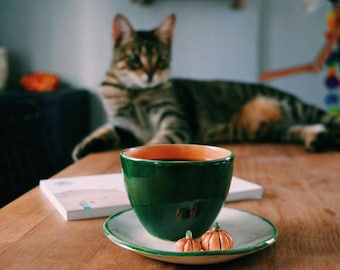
[{"xmin": 324, "ymin": 11, "xmax": 340, "ymax": 115}]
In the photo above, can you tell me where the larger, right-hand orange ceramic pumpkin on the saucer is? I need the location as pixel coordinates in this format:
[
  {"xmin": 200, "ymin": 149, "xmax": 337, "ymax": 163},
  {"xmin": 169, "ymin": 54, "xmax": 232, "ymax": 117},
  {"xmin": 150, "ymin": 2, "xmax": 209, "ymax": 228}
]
[{"xmin": 201, "ymin": 222, "xmax": 234, "ymax": 251}]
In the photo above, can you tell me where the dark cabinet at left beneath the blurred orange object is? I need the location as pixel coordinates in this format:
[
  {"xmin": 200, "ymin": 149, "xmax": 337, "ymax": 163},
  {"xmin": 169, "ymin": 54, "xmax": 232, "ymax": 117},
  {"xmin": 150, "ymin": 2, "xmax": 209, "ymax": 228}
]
[{"xmin": 0, "ymin": 89, "xmax": 90, "ymax": 207}]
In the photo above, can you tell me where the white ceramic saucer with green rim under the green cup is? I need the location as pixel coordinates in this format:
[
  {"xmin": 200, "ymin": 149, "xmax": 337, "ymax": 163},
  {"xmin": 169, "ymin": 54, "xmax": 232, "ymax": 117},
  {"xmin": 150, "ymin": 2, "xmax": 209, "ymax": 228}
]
[{"xmin": 103, "ymin": 207, "xmax": 278, "ymax": 264}]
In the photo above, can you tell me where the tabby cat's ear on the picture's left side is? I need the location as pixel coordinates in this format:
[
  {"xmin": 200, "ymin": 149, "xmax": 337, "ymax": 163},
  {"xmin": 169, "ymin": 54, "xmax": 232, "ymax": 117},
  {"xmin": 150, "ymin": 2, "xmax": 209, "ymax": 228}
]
[{"xmin": 112, "ymin": 14, "xmax": 134, "ymax": 46}]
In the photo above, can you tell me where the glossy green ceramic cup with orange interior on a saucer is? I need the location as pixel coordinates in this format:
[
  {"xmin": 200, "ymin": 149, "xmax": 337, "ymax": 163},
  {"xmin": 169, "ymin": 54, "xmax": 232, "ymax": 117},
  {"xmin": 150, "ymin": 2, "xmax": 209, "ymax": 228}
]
[{"xmin": 120, "ymin": 144, "xmax": 234, "ymax": 241}]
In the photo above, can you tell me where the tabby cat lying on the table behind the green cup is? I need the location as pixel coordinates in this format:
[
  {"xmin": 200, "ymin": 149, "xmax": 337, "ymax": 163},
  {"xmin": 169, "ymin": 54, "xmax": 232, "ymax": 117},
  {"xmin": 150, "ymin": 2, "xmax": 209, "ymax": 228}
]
[{"xmin": 73, "ymin": 14, "xmax": 340, "ymax": 160}]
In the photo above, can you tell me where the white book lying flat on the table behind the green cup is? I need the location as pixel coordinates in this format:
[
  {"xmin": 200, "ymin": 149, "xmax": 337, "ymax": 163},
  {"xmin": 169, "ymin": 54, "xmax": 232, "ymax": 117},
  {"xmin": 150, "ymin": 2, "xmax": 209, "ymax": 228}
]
[{"xmin": 39, "ymin": 173, "xmax": 263, "ymax": 220}]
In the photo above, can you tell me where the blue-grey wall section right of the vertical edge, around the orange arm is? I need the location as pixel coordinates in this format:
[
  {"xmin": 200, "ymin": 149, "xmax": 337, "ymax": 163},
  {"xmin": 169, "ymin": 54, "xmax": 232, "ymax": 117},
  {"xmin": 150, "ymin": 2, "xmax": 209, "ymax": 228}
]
[{"xmin": 261, "ymin": 0, "xmax": 332, "ymax": 114}]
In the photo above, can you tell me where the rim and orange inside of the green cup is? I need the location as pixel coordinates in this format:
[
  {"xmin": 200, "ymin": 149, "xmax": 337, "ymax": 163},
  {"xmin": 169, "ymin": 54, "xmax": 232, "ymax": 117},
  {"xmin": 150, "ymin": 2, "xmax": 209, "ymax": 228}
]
[{"xmin": 120, "ymin": 144, "xmax": 234, "ymax": 163}]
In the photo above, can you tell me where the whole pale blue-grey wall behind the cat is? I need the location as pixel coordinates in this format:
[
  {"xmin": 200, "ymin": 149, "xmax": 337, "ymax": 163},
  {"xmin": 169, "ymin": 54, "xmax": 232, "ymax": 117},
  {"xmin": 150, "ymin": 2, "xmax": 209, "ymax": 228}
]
[{"xmin": 0, "ymin": 0, "xmax": 330, "ymax": 127}]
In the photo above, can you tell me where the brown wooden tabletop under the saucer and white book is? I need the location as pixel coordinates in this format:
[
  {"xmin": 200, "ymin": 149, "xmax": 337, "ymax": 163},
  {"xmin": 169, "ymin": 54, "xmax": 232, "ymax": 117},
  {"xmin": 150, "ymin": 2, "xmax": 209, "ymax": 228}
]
[{"xmin": 0, "ymin": 144, "xmax": 340, "ymax": 270}]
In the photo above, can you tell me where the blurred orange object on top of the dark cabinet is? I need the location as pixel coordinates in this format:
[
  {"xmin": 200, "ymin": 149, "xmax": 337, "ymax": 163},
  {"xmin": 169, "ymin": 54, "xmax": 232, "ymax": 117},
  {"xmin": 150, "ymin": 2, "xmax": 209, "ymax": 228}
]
[{"xmin": 21, "ymin": 72, "xmax": 60, "ymax": 92}]
